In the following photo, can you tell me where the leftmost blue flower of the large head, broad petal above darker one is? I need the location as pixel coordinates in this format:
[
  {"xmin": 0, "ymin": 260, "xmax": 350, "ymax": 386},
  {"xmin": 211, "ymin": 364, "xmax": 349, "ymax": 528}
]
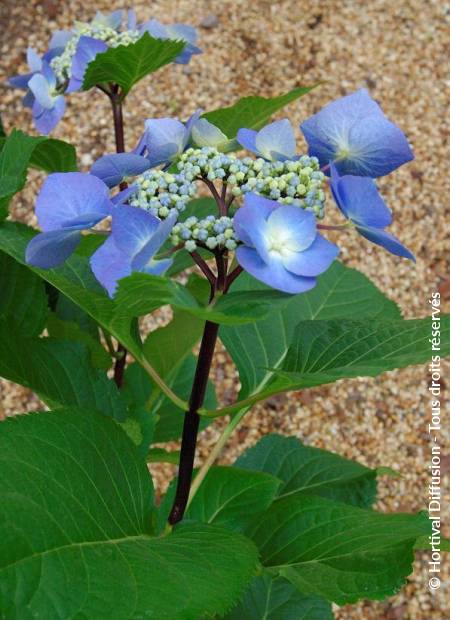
[{"xmin": 25, "ymin": 172, "xmax": 114, "ymax": 269}]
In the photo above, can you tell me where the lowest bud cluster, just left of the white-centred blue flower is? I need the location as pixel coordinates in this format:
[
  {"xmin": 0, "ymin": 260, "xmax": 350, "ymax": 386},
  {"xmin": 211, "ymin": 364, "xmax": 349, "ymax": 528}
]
[{"xmin": 171, "ymin": 215, "xmax": 237, "ymax": 252}]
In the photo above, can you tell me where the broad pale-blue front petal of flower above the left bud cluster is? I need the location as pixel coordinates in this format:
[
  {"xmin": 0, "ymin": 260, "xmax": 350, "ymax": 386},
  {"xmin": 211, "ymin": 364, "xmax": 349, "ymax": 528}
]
[{"xmin": 145, "ymin": 118, "xmax": 189, "ymax": 167}]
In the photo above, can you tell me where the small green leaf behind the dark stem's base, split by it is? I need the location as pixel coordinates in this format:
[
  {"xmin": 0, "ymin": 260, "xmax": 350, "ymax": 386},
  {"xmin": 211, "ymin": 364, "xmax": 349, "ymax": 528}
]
[{"xmin": 158, "ymin": 467, "xmax": 280, "ymax": 529}]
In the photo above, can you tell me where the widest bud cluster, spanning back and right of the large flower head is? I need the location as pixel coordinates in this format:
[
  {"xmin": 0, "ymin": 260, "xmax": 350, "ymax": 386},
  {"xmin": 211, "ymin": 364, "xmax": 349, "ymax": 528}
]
[{"xmin": 174, "ymin": 147, "xmax": 325, "ymax": 218}]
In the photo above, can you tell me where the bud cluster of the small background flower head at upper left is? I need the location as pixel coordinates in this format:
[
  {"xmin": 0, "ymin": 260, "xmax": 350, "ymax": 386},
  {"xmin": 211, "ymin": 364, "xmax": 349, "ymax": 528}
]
[{"xmin": 50, "ymin": 22, "xmax": 141, "ymax": 85}]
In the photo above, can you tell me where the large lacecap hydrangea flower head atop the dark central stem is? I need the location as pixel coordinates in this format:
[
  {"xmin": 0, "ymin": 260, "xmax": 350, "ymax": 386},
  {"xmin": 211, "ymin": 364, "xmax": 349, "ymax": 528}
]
[{"xmin": 27, "ymin": 91, "xmax": 414, "ymax": 296}]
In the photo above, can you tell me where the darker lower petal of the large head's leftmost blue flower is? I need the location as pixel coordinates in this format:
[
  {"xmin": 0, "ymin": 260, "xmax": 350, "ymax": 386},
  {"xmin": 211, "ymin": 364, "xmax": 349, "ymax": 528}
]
[{"xmin": 25, "ymin": 228, "xmax": 81, "ymax": 269}]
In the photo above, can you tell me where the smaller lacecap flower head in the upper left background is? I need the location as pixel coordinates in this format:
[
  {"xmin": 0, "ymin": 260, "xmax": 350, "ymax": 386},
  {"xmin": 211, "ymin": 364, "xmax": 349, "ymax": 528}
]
[{"xmin": 9, "ymin": 10, "xmax": 201, "ymax": 134}]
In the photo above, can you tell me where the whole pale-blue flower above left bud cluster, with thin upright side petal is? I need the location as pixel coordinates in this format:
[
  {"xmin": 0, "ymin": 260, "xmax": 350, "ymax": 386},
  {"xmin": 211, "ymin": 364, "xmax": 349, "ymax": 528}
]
[{"xmin": 134, "ymin": 110, "xmax": 201, "ymax": 168}]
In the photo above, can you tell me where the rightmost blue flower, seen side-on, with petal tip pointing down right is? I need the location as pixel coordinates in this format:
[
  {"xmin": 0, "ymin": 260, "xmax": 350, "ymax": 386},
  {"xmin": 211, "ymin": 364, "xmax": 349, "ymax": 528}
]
[{"xmin": 330, "ymin": 164, "xmax": 416, "ymax": 261}]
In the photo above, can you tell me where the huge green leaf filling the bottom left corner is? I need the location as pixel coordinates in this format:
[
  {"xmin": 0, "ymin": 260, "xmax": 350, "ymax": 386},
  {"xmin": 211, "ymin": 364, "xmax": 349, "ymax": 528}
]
[{"xmin": 0, "ymin": 410, "xmax": 257, "ymax": 620}]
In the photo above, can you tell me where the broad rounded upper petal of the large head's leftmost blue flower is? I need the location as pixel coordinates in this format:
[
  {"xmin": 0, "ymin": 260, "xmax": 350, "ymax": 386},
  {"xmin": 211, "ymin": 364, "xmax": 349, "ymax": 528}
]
[{"xmin": 36, "ymin": 172, "xmax": 112, "ymax": 231}]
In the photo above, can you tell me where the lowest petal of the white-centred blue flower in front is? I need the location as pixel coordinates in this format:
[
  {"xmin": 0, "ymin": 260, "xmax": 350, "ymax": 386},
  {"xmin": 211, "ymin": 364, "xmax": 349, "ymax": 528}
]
[{"xmin": 236, "ymin": 246, "xmax": 316, "ymax": 294}]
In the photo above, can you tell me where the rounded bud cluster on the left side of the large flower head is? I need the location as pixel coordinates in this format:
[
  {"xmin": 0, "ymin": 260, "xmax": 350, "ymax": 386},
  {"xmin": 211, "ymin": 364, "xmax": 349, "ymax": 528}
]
[{"xmin": 129, "ymin": 170, "xmax": 196, "ymax": 219}]
